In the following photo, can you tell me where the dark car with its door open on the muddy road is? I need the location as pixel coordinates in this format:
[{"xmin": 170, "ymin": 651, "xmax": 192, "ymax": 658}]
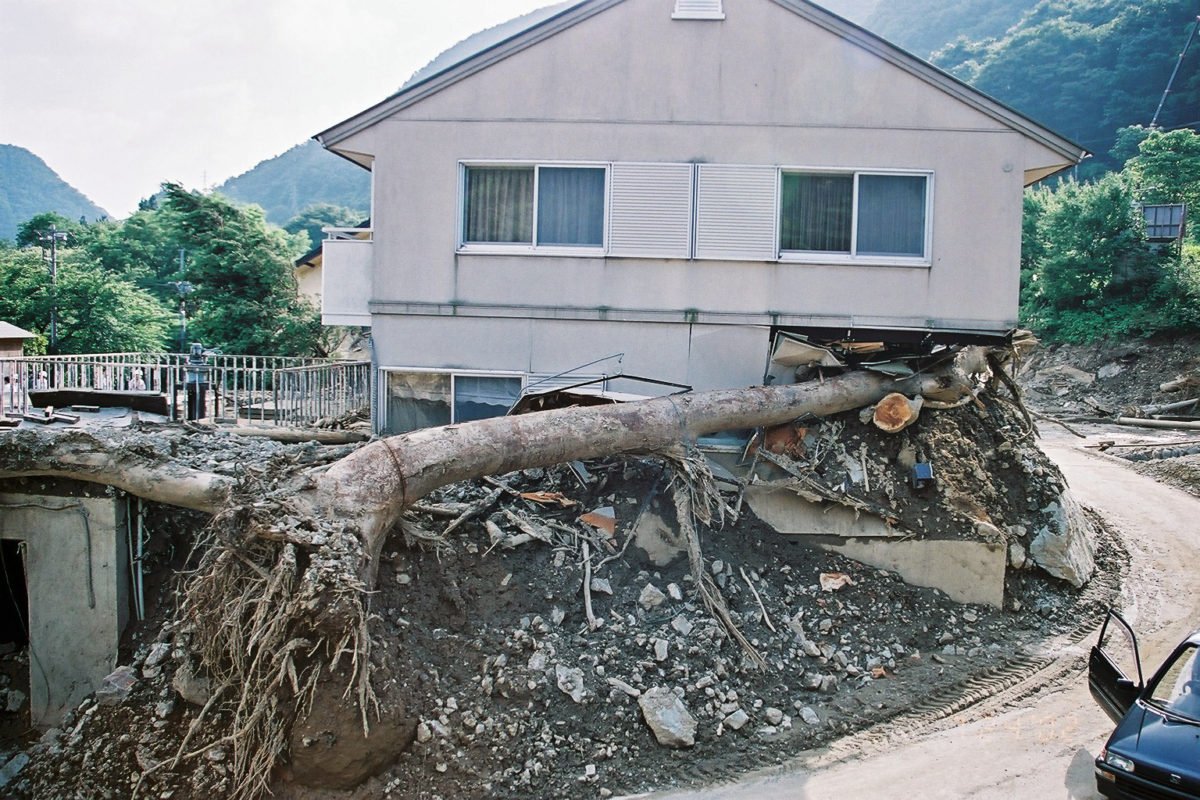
[{"xmin": 1087, "ymin": 610, "xmax": 1200, "ymax": 800}]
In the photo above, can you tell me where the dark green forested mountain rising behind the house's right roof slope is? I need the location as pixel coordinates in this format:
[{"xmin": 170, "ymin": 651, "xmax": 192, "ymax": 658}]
[{"xmin": 936, "ymin": 0, "xmax": 1200, "ymax": 175}]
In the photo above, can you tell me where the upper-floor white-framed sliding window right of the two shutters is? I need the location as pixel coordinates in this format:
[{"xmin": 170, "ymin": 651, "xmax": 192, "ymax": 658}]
[{"xmin": 779, "ymin": 168, "xmax": 932, "ymax": 264}]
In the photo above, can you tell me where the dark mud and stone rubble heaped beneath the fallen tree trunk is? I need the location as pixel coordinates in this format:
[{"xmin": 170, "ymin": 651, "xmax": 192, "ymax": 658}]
[{"xmin": 0, "ymin": 383, "xmax": 1120, "ymax": 800}]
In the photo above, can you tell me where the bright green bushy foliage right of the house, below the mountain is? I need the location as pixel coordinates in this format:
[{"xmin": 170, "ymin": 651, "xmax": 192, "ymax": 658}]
[{"xmin": 1021, "ymin": 128, "xmax": 1200, "ymax": 342}]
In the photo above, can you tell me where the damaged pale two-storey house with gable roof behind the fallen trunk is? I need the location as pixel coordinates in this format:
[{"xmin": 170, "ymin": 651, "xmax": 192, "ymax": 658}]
[{"xmin": 316, "ymin": 0, "xmax": 1086, "ymax": 433}]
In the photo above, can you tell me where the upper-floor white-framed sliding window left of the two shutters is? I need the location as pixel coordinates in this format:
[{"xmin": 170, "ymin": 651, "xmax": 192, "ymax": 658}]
[{"xmin": 460, "ymin": 163, "xmax": 608, "ymax": 255}]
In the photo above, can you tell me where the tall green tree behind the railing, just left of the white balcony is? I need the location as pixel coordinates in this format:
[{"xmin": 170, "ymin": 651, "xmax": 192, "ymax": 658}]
[{"xmin": 160, "ymin": 184, "xmax": 320, "ymax": 355}]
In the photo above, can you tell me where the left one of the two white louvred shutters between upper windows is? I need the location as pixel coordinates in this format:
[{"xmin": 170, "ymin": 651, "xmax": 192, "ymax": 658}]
[{"xmin": 608, "ymin": 163, "xmax": 691, "ymax": 258}]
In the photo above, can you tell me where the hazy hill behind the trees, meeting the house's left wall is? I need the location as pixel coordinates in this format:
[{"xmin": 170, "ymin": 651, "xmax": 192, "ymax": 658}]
[{"xmin": 216, "ymin": 140, "xmax": 371, "ymax": 225}]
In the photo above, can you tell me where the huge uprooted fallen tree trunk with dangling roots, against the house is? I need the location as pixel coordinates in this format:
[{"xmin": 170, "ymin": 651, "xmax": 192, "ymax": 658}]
[{"xmin": 0, "ymin": 348, "xmax": 989, "ymax": 799}]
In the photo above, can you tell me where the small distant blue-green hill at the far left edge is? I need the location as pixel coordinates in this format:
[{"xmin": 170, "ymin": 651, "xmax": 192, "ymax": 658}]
[{"xmin": 0, "ymin": 144, "xmax": 108, "ymax": 240}]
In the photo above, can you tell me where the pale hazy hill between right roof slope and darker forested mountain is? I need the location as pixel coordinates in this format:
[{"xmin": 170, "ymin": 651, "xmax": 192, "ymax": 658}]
[{"xmin": 865, "ymin": 0, "xmax": 1038, "ymax": 59}]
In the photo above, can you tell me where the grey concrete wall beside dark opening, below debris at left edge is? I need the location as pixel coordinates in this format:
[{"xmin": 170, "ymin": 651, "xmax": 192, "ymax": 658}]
[{"xmin": 0, "ymin": 493, "xmax": 130, "ymax": 729}]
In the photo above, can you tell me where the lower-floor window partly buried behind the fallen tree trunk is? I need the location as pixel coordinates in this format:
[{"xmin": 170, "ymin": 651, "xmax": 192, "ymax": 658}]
[{"xmin": 383, "ymin": 367, "xmax": 524, "ymax": 434}]
